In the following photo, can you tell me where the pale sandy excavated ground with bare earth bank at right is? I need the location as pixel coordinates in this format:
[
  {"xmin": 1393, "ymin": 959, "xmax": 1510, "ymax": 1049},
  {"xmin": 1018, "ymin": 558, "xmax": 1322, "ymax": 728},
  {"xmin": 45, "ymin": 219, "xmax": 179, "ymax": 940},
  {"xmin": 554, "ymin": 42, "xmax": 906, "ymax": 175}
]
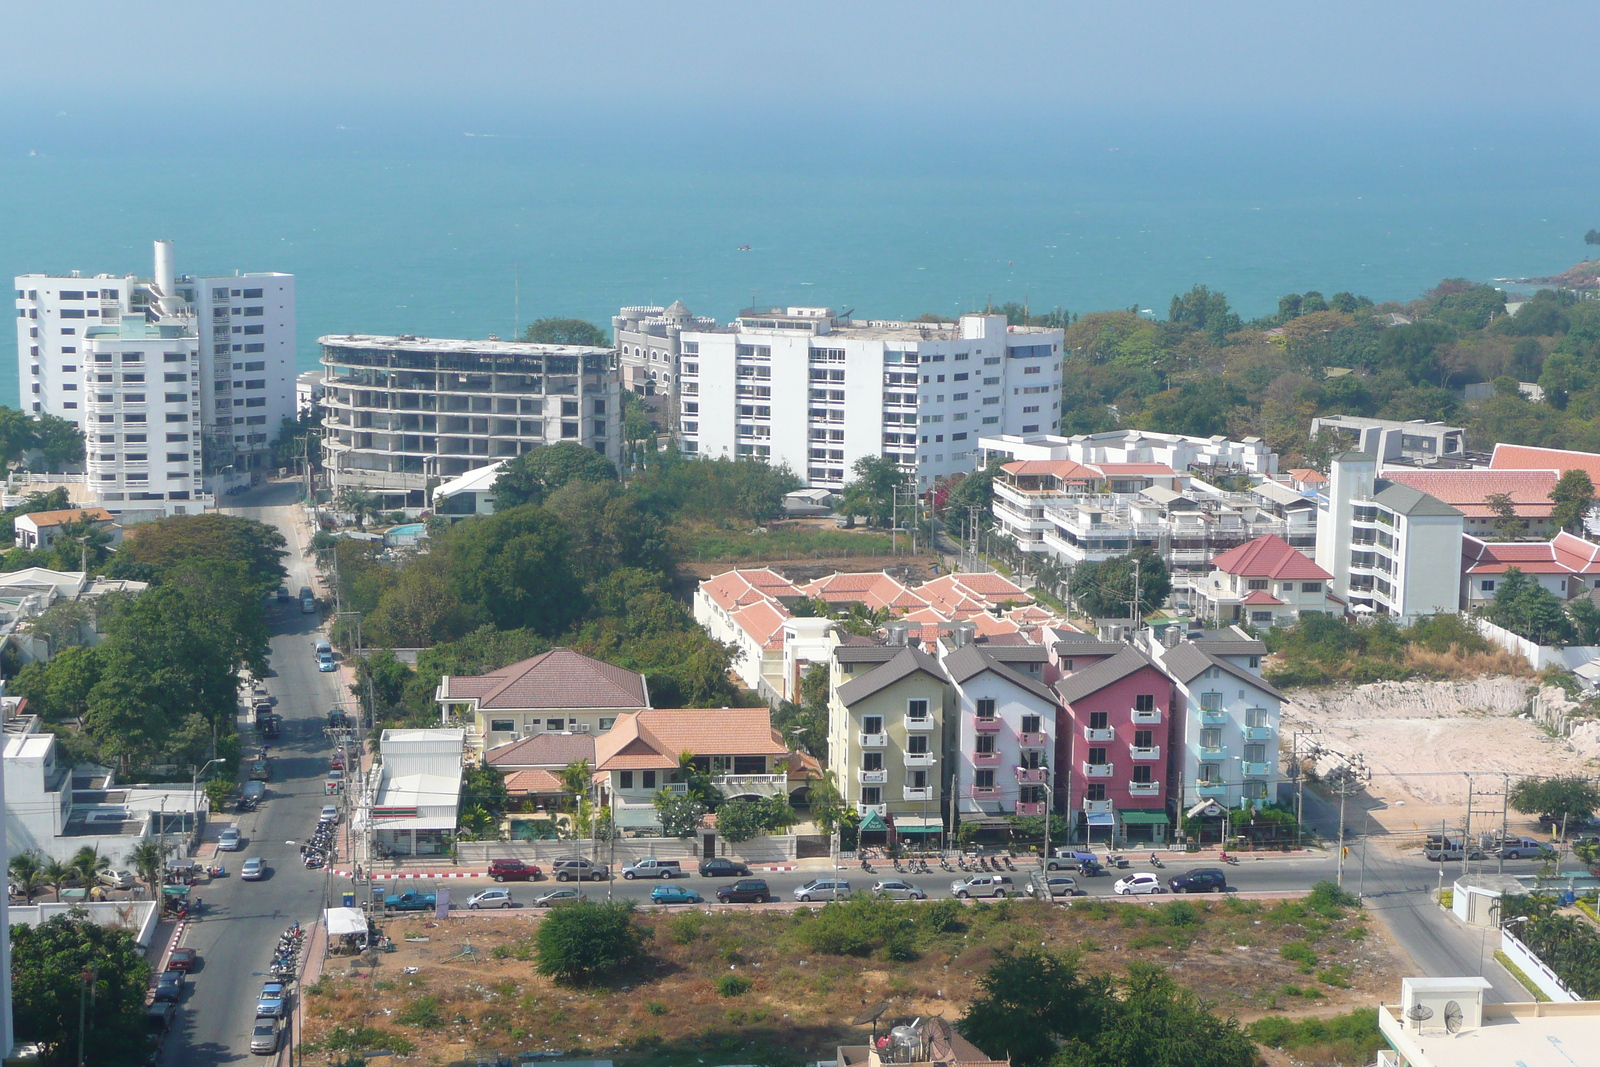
[{"xmin": 1282, "ymin": 677, "xmax": 1600, "ymax": 833}]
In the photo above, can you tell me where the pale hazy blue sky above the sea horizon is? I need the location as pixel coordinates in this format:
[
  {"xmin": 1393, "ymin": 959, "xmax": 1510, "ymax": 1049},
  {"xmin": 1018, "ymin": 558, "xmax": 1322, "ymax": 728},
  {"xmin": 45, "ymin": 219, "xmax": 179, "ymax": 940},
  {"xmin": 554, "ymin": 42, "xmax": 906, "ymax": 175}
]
[{"xmin": 12, "ymin": 0, "xmax": 1600, "ymax": 133}]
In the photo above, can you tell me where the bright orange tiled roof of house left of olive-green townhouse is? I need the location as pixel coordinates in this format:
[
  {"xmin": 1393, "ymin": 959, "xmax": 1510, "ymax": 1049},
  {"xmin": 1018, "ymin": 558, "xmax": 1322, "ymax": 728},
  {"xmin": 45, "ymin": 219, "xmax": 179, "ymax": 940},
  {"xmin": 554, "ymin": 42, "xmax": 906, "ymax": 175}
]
[{"xmin": 595, "ymin": 707, "xmax": 789, "ymax": 771}]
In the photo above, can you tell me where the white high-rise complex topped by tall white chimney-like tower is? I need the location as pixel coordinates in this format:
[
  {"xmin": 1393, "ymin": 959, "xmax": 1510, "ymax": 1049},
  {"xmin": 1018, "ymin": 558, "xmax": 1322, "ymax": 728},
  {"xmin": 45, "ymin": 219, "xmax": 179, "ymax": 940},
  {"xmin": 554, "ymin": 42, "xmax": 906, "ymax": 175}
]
[{"xmin": 16, "ymin": 242, "xmax": 296, "ymax": 486}]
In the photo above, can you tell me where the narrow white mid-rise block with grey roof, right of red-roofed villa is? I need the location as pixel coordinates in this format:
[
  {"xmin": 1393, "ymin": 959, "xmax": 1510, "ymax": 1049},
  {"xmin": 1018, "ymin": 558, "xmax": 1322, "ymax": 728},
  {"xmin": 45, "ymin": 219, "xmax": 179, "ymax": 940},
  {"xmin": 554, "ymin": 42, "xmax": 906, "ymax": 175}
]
[{"xmin": 1317, "ymin": 453, "xmax": 1462, "ymax": 622}]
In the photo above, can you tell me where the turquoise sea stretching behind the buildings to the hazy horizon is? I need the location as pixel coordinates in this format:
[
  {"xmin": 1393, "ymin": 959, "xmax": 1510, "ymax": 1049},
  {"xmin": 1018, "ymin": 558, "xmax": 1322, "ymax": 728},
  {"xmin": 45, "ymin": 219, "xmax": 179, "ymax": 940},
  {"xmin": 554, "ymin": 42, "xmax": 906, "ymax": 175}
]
[{"xmin": 0, "ymin": 125, "xmax": 1600, "ymax": 403}]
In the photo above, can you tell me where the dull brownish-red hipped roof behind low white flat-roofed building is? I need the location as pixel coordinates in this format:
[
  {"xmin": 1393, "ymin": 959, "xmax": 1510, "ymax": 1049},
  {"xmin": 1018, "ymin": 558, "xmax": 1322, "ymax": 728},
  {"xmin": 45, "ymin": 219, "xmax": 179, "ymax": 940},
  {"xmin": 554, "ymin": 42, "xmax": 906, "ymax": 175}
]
[{"xmin": 440, "ymin": 648, "xmax": 650, "ymax": 710}]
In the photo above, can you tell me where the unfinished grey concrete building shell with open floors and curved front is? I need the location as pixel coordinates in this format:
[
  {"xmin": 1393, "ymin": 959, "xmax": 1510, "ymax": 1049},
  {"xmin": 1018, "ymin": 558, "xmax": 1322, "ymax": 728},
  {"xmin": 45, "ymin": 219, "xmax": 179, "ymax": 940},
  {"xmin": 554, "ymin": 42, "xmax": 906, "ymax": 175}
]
[{"xmin": 317, "ymin": 334, "xmax": 622, "ymax": 509}]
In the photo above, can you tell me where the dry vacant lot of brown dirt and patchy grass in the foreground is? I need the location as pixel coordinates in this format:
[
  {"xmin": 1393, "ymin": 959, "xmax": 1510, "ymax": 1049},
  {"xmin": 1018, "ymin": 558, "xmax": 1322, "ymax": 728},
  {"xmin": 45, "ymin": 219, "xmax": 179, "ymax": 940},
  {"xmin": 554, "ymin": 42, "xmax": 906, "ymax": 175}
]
[{"xmin": 306, "ymin": 897, "xmax": 1403, "ymax": 1067}]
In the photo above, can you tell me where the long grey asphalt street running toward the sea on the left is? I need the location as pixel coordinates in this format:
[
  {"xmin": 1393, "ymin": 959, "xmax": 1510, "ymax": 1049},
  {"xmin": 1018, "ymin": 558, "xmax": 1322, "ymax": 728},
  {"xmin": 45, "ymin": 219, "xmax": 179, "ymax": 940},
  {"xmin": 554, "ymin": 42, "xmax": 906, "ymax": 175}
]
[{"xmin": 162, "ymin": 486, "xmax": 347, "ymax": 1067}]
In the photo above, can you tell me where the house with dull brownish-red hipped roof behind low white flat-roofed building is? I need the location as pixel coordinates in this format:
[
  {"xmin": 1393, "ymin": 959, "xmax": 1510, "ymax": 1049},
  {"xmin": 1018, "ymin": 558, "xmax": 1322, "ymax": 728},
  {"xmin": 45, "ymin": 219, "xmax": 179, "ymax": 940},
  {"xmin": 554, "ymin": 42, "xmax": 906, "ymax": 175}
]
[{"xmin": 434, "ymin": 648, "xmax": 650, "ymax": 752}]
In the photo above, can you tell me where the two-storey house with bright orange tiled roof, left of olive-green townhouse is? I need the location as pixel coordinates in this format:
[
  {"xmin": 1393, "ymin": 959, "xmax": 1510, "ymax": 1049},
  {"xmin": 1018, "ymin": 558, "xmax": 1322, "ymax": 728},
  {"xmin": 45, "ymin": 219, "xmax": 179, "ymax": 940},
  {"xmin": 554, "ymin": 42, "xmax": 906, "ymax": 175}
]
[{"xmin": 595, "ymin": 707, "xmax": 811, "ymax": 827}]
